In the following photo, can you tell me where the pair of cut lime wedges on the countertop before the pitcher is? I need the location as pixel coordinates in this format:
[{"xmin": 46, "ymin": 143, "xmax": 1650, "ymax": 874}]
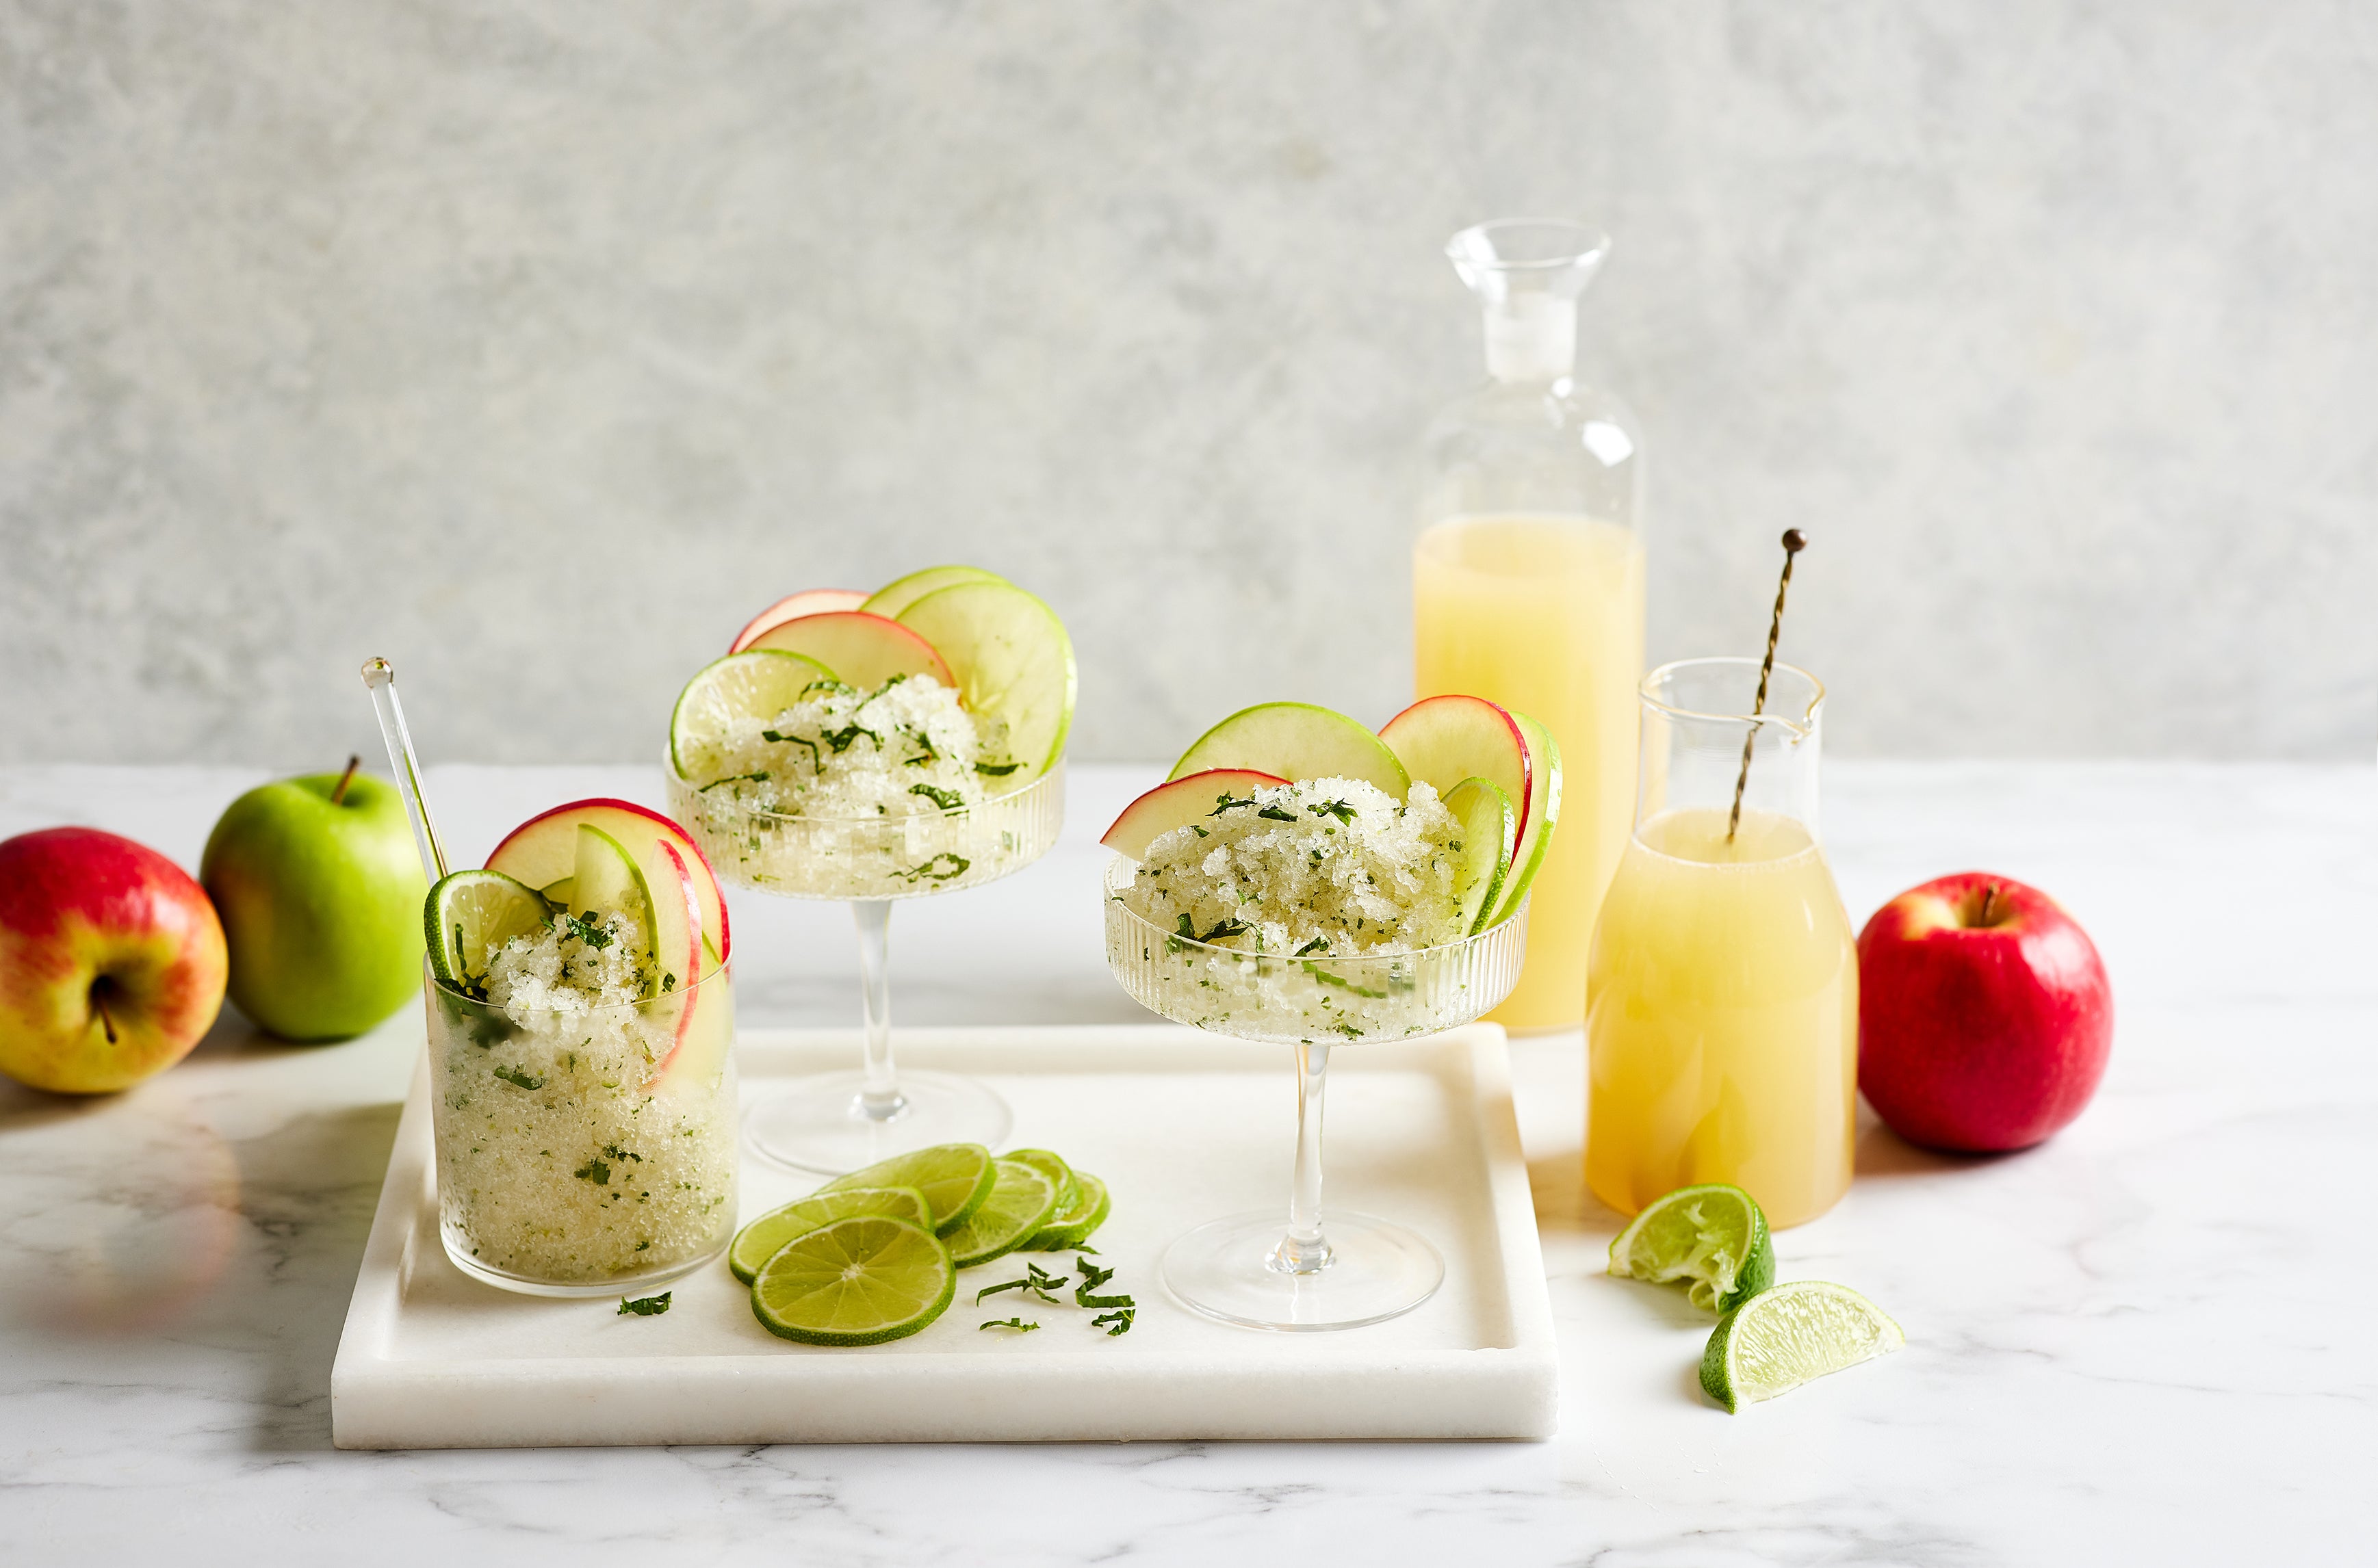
[{"xmin": 1610, "ymin": 1183, "xmax": 1907, "ymax": 1411}]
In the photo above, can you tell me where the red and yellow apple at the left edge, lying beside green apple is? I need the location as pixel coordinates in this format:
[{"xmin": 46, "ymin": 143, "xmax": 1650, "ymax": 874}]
[{"xmin": 0, "ymin": 827, "xmax": 231, "ymax": 1095}]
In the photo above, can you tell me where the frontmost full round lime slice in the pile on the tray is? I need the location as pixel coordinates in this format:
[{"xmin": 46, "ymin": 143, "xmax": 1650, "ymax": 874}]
[{"xmin": 751, "ymin": 1214, "xmax": 958, "ymax": 1345}]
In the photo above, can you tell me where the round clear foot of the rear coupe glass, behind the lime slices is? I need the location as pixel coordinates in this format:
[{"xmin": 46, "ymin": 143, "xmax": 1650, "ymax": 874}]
[{"xmin": 745, "ymin": 1071, "xmax": 1016, "ymax": 1176}]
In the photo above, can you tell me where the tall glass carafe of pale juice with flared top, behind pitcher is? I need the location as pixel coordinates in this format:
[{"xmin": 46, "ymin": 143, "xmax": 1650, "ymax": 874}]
[{"xmin": 1412, "ymin": 221, "xmax": 1643, "ymax": 1029}]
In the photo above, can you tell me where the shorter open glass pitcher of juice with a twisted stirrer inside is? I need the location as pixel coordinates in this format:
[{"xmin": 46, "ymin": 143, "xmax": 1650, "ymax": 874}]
[{"xmin": 1586, "ymin": 658, "xmax": 1857, "ymax": 1226}]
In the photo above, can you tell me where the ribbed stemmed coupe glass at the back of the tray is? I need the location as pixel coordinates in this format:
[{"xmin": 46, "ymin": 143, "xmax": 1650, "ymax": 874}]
[{"xmin": 661, "ymin": 758, "xmax": 1065, "ymax": 1176}]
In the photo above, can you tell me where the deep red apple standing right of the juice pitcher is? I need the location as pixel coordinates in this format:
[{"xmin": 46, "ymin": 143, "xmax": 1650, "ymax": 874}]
[{"xmin": 1857, "ymin": 872, "xmax": 2114, "ymax": 1150}]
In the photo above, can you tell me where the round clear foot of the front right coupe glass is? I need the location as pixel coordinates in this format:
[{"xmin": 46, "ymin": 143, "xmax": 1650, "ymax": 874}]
[{"xmin": 1163, "ymin": 1210, "xmax": 1446, "ymax": 1333}]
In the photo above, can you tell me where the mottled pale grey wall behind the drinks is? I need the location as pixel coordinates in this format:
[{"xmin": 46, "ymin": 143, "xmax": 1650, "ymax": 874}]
[{"xmin": 0, "ymin": 0, "xmax": 2378, "ymax": 765}]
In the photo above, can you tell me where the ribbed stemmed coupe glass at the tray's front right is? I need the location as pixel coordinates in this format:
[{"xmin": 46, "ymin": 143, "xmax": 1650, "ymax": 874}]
[{"xmin": 1106, "ymin": 855, "xmax": 1527, "ymax": 1333}]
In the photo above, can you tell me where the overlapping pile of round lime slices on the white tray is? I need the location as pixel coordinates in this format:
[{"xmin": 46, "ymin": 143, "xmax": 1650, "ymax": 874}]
[{"xmin": 727, "ymin": 1142, "xmax": 1108, "ymax": 1345}]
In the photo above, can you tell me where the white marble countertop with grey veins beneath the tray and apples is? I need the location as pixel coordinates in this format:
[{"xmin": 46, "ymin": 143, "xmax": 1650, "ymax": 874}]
[{"xmin": 0, "ymin": 760, "xmax": 2378, "ymax": 1568}]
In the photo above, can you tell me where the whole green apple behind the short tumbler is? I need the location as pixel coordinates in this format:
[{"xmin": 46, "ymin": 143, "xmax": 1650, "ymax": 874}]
[{"xmin": 197, "ymin": 763, "xmax": 428, "ymax": 1041}]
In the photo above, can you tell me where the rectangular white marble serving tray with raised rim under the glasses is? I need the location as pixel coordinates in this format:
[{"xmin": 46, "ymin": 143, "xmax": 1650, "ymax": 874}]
[{"xmin": 331, "ymin": 1024, "xmax": 1555, "ymax": 1449}]
